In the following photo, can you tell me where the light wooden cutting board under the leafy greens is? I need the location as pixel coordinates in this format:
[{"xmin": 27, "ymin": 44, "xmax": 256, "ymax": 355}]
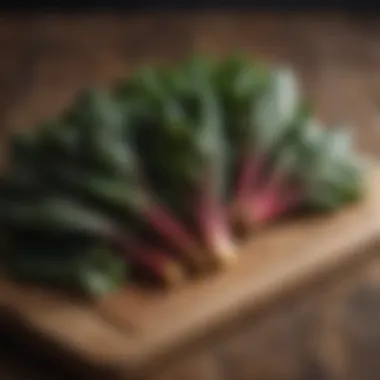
[{"xmin": 0, "ymin": 168, "xmax": 380, "ymax": 376}]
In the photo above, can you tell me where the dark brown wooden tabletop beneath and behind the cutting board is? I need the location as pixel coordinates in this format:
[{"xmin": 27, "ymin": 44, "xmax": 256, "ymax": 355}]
[{"xmin": 0, "ymin": 12, "xmax": 380, "ymax": 380}]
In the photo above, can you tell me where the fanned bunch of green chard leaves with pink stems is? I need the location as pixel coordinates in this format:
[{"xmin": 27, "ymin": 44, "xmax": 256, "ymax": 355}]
[{"xmin": 0, "ymin": 57, "xmax": 364, "ymax": 294}]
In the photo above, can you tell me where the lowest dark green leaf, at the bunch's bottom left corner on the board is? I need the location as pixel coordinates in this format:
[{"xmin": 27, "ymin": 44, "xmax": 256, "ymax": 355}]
[{"xmin": 9, "ymin": 243, "xmax": 127, "ymax": 297}]
